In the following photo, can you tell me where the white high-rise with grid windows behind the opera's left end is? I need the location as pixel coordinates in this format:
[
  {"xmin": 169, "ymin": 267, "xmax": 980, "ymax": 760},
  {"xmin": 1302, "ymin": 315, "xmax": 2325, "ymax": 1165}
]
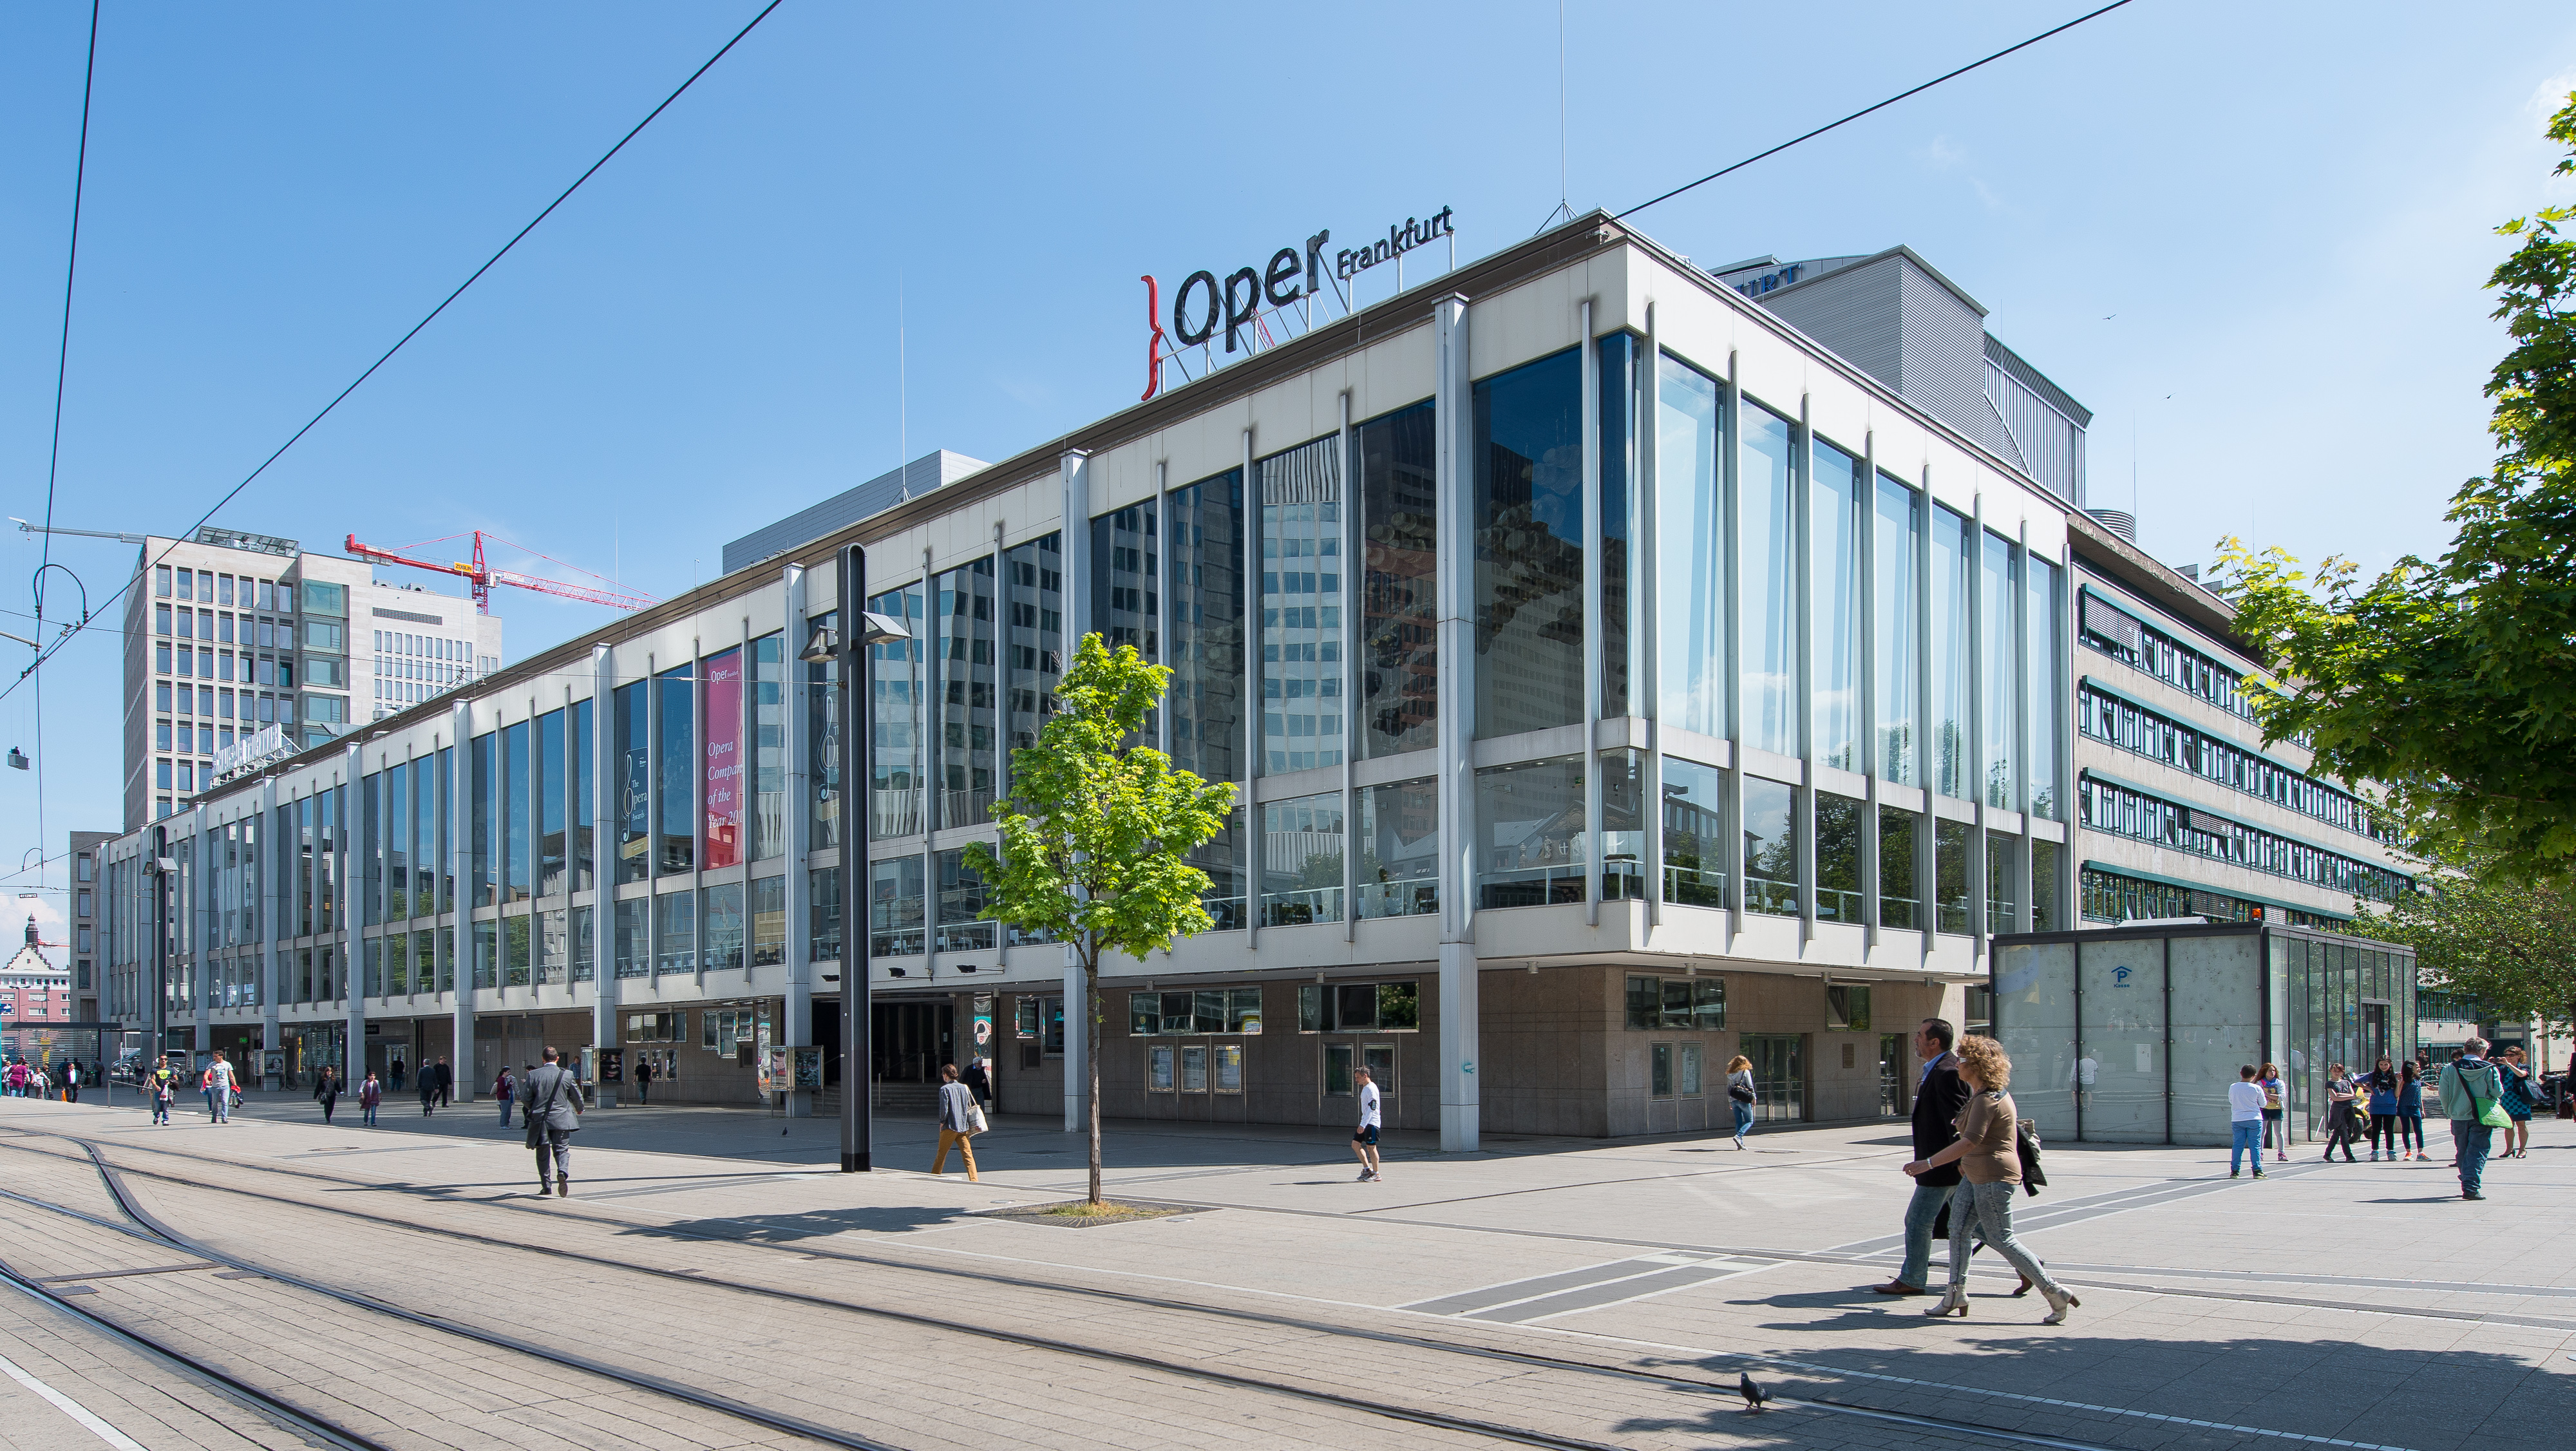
[{"xmin": 124, "ymin": 526, "xmax": 500, "ymax": 830}]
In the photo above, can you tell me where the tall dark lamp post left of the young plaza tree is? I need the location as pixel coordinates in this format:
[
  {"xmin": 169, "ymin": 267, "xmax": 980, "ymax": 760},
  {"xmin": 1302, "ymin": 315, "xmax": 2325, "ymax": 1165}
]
[{"xmin": 796, "ymin": 544, "xmax": 912, "ymax": 1173}]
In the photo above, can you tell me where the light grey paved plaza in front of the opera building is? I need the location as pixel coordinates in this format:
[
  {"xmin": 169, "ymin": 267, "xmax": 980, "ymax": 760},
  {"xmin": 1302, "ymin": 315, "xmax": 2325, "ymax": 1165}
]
[{"xmin": 0, "ymin": 1095, "xmax": 2576, "ymax": 1451}]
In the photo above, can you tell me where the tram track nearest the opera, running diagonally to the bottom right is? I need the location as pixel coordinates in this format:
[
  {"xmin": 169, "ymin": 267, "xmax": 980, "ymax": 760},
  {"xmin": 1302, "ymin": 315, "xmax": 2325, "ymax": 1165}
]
[{"xmin": 0, "ymin": 1129, "xmax": 2396, "ymax": 1451}]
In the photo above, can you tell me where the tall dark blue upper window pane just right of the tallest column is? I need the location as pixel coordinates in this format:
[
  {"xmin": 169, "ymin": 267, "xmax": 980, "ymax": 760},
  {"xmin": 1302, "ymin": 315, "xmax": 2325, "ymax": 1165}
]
[{"xmin": 1471, "ymin": 350, "xmax": 1584, "ymax": 740}]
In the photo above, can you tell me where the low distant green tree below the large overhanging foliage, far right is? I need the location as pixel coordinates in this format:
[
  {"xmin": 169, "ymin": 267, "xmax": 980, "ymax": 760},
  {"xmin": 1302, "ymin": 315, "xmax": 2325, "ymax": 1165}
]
[{"xmin": 2352, "ymin": 858, "xmax": 2576, "ymax": 1046}]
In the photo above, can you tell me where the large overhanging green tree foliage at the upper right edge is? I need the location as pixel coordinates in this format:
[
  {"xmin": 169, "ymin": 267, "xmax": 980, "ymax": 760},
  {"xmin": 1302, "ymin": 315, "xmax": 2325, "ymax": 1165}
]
[{"xmin": 2215, "ymin": 95, "xmax": 2576, "ymax": 882}]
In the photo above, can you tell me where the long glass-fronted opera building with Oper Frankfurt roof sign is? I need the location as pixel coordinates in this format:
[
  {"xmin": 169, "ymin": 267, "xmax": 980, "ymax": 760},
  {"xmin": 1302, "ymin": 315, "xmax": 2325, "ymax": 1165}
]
[{"xmin": 86, "ymin": 214, "xmax": 2411, "ymax": 1150}]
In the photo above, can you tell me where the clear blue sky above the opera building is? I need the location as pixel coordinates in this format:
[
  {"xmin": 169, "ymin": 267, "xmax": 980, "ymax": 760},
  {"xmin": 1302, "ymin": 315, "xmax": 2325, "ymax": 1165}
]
[{"xmin": 0, "ymin": 0, "xmax": 2576, "ymax": 936}]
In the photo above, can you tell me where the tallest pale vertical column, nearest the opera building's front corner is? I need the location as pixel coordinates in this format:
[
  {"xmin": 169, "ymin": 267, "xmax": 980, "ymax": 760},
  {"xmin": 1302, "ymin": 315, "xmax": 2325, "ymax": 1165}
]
[{"xmin": 1432, "ymin": 294, "xmax": 1484, "ymax": 1155}]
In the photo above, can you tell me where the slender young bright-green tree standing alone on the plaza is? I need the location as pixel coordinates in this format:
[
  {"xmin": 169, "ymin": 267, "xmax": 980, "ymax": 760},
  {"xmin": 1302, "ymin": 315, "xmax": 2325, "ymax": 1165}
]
[{"xmin": 966, "ymin": 634, "xmax": 1234, "ymax": 1206}]
